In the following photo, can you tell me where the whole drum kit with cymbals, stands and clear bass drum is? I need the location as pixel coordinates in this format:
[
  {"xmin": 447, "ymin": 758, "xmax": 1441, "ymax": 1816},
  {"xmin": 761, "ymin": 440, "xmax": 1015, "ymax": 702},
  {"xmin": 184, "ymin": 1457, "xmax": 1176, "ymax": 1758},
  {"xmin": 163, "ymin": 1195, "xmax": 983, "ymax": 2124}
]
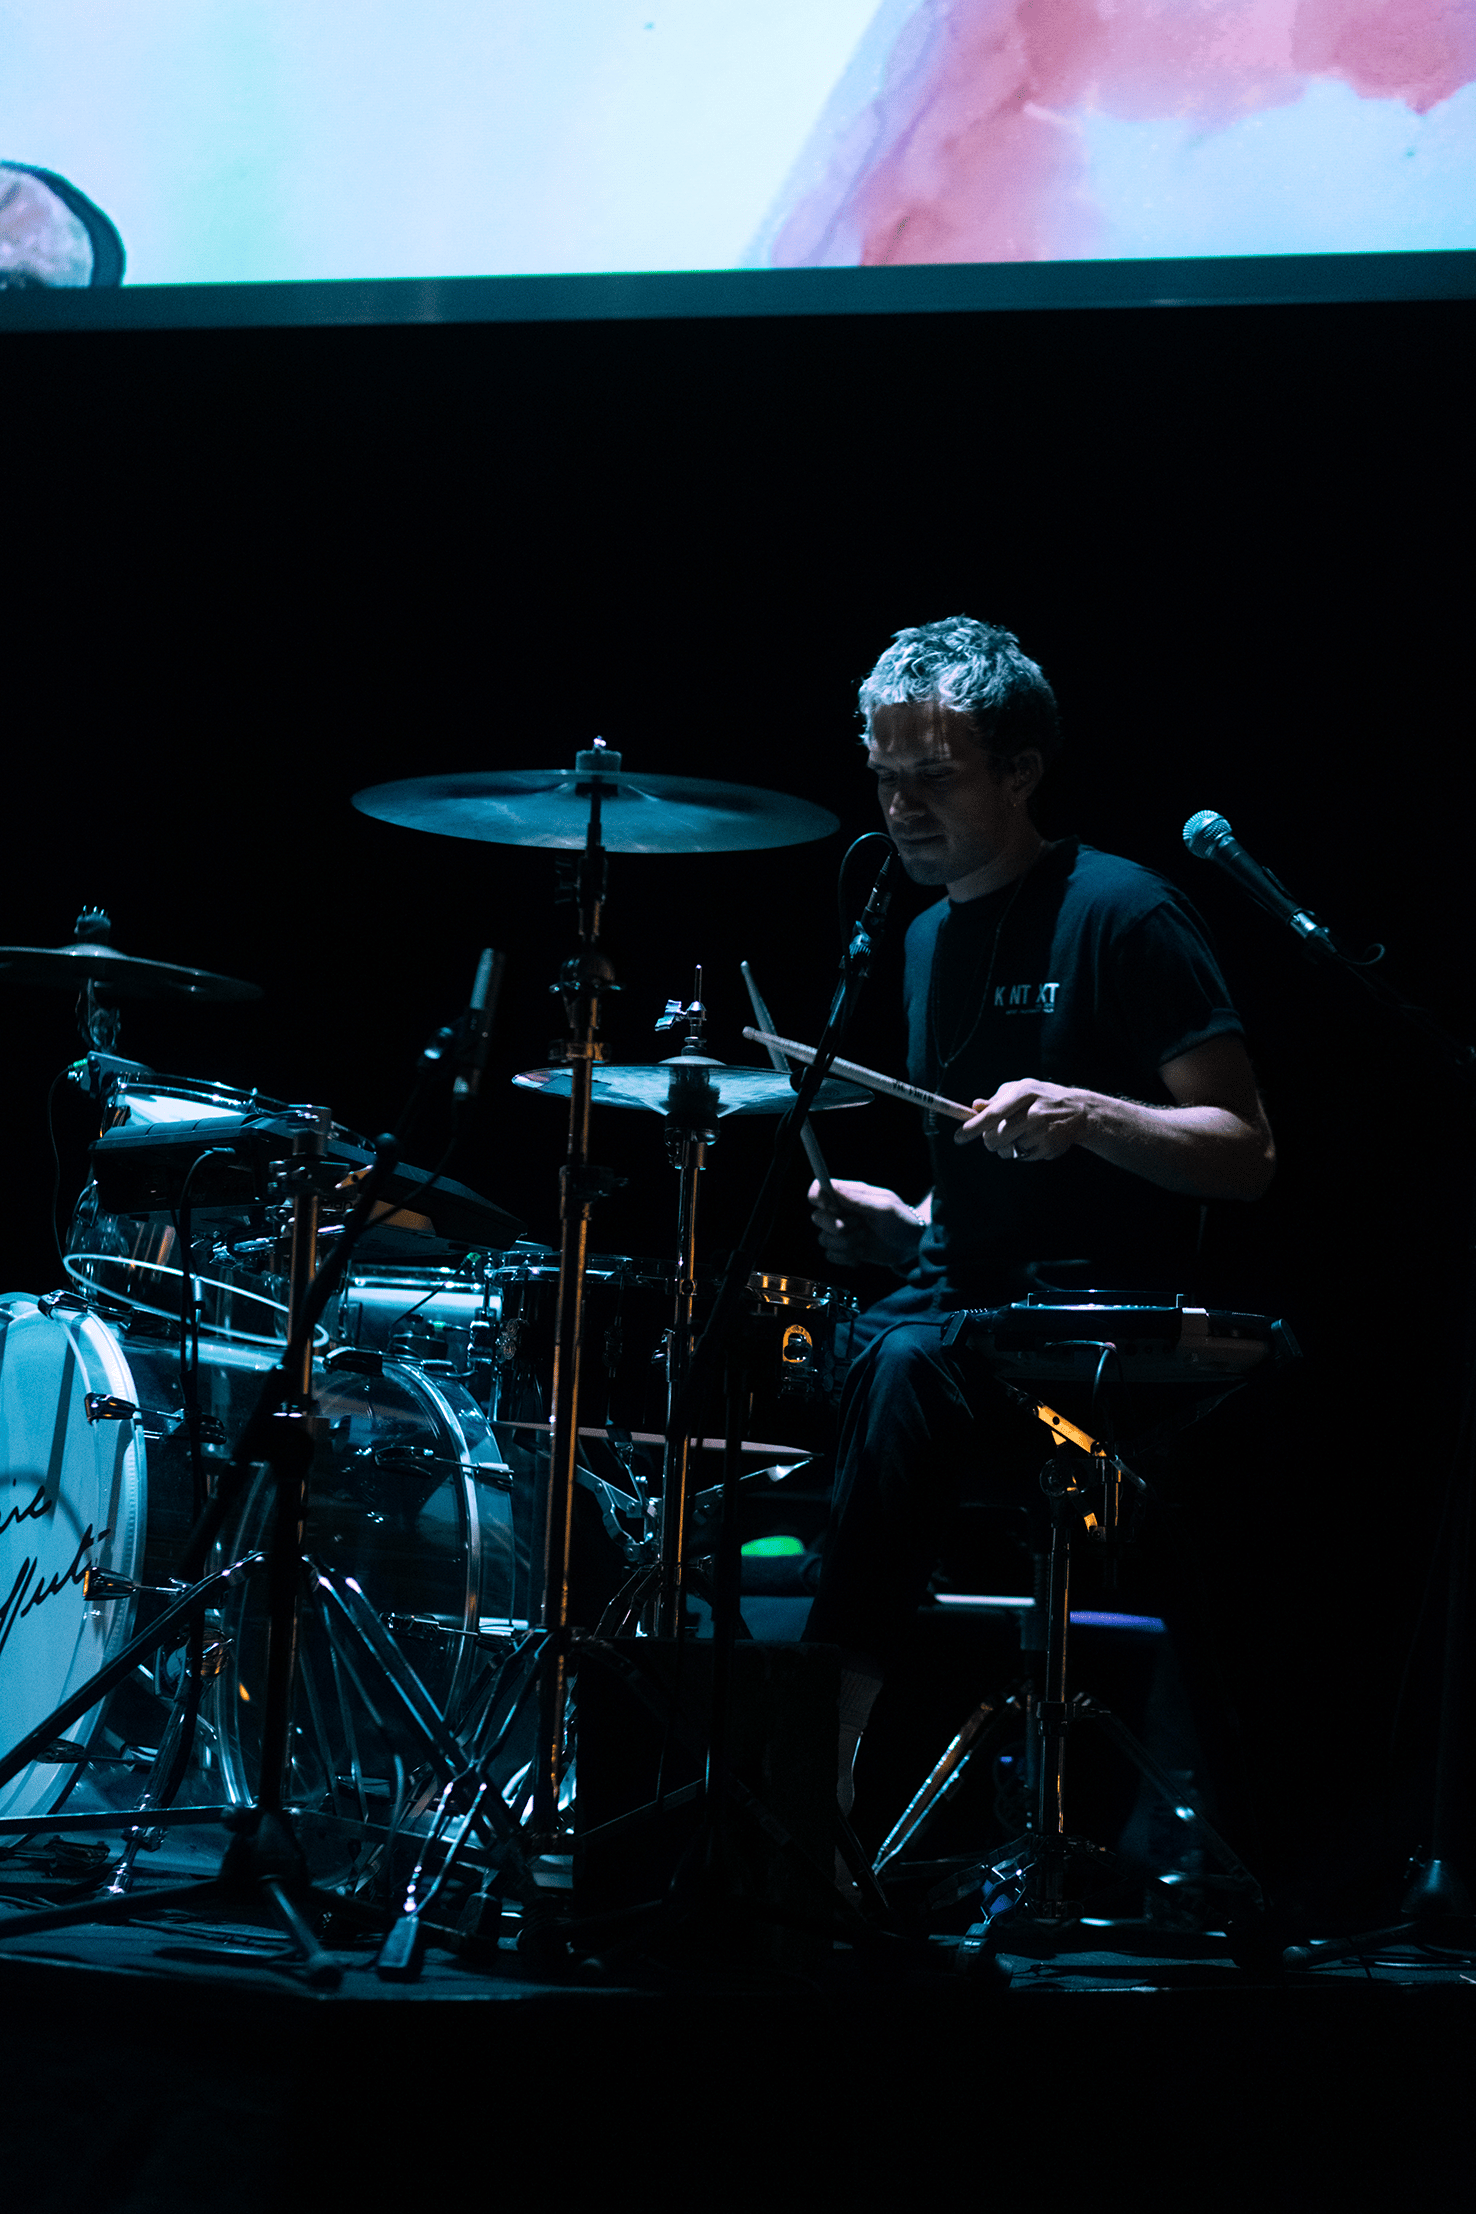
[{"xmin": 0, "ymin": 742, "xmax": 911, "ymax": 1979}]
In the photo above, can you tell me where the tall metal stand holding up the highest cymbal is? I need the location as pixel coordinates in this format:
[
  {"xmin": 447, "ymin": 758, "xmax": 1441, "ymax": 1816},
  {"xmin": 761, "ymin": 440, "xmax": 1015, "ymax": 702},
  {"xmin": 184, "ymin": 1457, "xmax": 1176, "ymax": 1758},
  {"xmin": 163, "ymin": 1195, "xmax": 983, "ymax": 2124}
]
[{"xmin": 531, "ymin": 742, "xmax": 624, "ymax": 1851}]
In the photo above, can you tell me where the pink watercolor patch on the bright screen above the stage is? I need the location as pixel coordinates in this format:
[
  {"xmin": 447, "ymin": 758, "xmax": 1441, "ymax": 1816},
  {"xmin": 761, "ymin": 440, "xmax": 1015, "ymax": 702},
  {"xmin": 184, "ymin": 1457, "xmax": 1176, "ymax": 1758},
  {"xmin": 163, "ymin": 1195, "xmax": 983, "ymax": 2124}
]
[{"xmin": 772, "ymin": 0, "xmax": 1476, "ymax": 266}]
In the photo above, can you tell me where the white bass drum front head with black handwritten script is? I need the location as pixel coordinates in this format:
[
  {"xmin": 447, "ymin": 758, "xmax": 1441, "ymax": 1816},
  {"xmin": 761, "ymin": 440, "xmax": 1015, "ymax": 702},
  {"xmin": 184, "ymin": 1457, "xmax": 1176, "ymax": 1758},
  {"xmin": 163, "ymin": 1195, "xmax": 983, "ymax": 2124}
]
[{"xmin": 0, "ymin": 1293, "xmax": 270, "ymax": 1815}]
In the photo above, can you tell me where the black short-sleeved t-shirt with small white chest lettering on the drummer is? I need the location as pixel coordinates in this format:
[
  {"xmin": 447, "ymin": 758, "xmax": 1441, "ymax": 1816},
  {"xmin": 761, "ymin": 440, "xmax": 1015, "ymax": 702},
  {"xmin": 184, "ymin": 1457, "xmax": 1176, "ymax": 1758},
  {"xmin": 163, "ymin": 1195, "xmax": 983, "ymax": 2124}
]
[{"xmin": 903, "ymin": 839, "xmax": 1241, "ymax": 1302}]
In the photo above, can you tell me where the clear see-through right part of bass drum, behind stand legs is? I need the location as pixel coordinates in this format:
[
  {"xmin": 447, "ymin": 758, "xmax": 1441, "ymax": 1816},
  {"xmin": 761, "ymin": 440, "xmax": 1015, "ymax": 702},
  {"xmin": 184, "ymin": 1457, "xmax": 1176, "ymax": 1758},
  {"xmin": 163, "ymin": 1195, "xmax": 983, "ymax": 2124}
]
[{"xmin": 201, "ymin": 1351, "xmax": 527, "ymax": 1877}]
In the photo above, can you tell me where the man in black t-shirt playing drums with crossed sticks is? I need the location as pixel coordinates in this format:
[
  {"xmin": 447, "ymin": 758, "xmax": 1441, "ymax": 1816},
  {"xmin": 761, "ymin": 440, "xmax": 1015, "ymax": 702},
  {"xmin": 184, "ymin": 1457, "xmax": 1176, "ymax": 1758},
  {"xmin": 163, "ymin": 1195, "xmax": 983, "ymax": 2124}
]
[{"xmin": 805, "ymin": 615, "xmax": 1275, "ymax": 1813}]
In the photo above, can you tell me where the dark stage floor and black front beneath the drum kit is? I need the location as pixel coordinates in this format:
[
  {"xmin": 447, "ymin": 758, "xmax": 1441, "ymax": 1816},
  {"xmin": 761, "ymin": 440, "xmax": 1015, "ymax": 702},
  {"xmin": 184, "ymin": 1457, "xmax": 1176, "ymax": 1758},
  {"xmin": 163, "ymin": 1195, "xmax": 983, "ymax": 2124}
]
[{"xmin": 0, "ymin": 1900, "xmax": 1476, "ymax": 2214}]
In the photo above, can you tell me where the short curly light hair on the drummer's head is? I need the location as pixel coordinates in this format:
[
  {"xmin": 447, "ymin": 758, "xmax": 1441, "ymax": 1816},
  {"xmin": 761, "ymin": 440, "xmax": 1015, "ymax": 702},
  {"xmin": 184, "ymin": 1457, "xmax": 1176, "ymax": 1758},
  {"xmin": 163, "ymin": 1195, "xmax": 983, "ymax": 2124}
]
[{"xmin": 859, "ymin": 615, "xmax": 1062, "ymax": 766}]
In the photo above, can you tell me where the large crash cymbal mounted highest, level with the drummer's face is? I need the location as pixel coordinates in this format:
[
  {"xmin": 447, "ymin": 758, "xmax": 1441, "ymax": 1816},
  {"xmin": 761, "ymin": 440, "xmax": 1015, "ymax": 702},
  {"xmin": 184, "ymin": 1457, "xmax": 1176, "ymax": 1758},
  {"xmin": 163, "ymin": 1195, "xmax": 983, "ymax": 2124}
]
[{"xmin": 354, "ymin": 770, "xmax": 839, "ymax": 852}]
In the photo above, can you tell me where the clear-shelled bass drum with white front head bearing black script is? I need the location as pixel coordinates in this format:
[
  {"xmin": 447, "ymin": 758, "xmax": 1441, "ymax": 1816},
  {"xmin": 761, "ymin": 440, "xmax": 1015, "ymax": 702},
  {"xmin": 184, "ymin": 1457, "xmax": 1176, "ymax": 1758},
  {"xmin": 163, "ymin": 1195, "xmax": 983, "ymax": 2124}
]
[{"xmin": 0, "ymin": 1295, "xmax": 513, "ymax": 1813}]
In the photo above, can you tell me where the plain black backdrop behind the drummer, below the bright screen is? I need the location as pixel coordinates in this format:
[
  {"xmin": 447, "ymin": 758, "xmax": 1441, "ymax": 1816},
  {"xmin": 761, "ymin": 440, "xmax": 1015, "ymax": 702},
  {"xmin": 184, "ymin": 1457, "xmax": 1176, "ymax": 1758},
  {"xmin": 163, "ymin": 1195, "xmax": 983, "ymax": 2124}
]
[{"xmin": 0, "ymin": 306, "xmax": 1476, "ymax": 1921}]
